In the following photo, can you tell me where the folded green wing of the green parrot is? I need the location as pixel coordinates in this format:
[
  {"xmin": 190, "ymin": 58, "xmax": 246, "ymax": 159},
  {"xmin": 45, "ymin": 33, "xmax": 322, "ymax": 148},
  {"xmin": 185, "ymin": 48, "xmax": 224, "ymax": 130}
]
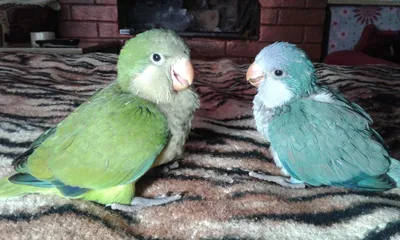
[{"xmin": 16, "ymin": 84, "xmax": 169, "ymax": 189}]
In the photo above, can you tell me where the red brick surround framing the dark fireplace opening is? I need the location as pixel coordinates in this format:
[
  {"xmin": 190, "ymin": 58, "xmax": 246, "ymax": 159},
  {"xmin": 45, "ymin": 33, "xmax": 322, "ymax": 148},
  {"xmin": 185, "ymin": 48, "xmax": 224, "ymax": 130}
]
[{"xmin": 59, "ymin": 0, "xmax": 326, "ymax": 61}]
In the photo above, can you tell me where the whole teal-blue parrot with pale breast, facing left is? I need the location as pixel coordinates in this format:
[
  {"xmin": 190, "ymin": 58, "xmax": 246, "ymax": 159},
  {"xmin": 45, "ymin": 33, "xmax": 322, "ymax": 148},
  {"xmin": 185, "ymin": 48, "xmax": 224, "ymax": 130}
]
[{"xmin": 246, "ymin": 42, "xmax": 400, "ymax": 191}]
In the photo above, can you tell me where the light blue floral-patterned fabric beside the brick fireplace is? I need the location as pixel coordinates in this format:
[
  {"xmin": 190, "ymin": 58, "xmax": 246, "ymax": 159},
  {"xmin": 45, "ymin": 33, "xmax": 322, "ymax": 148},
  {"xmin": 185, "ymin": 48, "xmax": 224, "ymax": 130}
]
[{"xmin": 328, "ymin": 6, "xmax": 400, "ymax": 54}]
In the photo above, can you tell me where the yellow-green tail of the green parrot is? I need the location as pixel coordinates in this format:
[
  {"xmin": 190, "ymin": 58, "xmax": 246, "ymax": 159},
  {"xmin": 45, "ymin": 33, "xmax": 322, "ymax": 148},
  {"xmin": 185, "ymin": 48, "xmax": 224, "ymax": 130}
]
[{"xmin": 0, "ymin": 177, "xmax": 57, "ymax": 199}]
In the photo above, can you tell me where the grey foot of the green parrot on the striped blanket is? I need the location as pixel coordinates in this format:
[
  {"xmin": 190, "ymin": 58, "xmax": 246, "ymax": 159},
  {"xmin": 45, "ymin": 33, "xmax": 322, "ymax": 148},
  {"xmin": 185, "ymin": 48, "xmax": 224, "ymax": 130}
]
[{"xmin": 108, "ymin": 194, "xmax": 181, "ymax": 212}]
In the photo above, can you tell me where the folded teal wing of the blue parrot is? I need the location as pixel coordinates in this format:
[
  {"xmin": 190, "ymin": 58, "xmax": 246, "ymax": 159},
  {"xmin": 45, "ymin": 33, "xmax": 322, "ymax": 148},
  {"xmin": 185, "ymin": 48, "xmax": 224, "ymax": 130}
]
[{"xmin": 269, "ymin": 91, "xmax": 395, "ymax": 190}]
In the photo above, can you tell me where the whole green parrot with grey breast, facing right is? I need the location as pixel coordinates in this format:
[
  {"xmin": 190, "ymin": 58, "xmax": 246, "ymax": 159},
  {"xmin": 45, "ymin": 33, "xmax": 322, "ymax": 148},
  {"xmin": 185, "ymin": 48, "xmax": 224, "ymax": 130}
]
[{"xmin": 0, "ymin": 29, "xmax": 199, "ymax": 211}]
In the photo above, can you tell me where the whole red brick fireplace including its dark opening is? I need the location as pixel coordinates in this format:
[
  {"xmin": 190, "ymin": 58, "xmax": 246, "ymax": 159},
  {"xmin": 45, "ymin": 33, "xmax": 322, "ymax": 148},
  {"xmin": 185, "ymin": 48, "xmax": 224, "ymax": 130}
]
[{"xmin": 58, "ymin": 0, "xmax": 326, "ymax": 62}]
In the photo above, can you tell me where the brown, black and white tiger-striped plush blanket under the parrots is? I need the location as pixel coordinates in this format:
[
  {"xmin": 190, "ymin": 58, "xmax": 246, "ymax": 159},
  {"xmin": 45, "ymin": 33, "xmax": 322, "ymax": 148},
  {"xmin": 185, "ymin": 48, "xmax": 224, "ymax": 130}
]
[{"xmin": 0, "ymin": 53, "xmax": 400, "ymax": 239}]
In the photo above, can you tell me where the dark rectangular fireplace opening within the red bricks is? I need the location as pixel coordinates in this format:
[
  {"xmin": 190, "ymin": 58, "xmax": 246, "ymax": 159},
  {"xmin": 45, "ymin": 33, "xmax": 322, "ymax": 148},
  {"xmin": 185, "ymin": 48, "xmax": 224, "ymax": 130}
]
[{"xmin": 118, "ymin": 0, "xmax": 260, "ymax": 39}]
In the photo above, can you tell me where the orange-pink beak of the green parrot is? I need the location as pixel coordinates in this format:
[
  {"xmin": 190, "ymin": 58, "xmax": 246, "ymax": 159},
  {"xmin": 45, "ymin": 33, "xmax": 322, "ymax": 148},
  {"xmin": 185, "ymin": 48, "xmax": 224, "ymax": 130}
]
[{"xmin": 171, "ymin": 59, "xmax": 194, "ymax": 91}]
